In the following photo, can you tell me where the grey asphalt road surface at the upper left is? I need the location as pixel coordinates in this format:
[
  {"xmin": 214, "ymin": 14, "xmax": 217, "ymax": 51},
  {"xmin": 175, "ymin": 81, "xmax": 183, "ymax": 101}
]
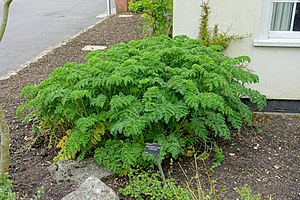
[{"xmin": 0, "ymin": 0, "xmax": 112, "ymax": 79}]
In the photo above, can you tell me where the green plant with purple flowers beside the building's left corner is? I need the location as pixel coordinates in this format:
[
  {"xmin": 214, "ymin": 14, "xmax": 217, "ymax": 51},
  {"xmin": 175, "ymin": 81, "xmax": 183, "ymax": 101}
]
[{"xmin": 129, "ymin": 0, "xmax": 173, "ymax": 37}]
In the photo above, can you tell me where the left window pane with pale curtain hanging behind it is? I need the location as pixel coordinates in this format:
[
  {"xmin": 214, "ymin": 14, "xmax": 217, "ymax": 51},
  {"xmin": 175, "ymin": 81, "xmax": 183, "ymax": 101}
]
[{"xmin": 271, "ymin": 3, "xmax": 294, "ymax": 31}]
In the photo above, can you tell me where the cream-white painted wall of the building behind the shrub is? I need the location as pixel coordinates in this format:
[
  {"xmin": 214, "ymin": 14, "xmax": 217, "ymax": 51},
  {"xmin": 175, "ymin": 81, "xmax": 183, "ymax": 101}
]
[{"xmin": 173, "ymin": 0, "xmax": 300, "ymax": 100}]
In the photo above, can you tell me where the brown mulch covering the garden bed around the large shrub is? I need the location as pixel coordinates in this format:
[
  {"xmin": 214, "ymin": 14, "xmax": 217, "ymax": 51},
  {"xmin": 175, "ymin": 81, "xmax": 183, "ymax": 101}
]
[{"xmin": 0, "ymin": 15, "xmax": 300, "ymax": 200}]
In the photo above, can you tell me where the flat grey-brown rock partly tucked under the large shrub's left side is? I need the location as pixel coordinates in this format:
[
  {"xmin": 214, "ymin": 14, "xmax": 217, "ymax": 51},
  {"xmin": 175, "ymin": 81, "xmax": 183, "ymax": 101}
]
[{"xmin": 48, "ymin": 158, "xmax": 113, "ymax": 184}]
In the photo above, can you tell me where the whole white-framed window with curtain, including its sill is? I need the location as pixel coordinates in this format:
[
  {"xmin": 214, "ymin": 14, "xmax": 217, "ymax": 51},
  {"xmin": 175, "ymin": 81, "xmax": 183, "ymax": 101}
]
[{"xmin": 254, "ymin": 0, "xmax": 300, "ymax": 47}]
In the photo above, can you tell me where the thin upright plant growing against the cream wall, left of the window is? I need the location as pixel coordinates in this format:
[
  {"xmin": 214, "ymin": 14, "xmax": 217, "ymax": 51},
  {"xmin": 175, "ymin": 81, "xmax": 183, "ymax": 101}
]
[{"xmin": 199, "ymin": 2, "xmax": 250, "ymax": 49}]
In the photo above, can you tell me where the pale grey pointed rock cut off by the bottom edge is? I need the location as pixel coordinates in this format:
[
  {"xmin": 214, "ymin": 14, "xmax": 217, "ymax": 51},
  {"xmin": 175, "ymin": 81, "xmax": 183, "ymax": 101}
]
[{"xmin": 62, "ymin": 176, "xmax": 119, "ymax": 200}]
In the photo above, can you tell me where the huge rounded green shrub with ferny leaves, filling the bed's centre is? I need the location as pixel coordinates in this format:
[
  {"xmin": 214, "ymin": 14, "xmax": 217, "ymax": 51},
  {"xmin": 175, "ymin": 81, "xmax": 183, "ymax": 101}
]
[{"xmin": 17, "ymin": 36, "xmax": 265, "ymax": 173}]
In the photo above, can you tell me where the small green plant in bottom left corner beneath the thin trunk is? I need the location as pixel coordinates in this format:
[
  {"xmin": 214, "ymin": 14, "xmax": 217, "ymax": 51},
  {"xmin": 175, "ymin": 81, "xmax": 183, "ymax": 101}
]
[{"xmin": 0, "ymin": 173, "xmax": 15, "ymax": 200}]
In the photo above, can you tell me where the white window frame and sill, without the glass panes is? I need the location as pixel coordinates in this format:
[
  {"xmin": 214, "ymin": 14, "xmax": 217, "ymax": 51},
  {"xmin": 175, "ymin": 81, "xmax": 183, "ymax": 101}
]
[{"xmin": 254, "ymin": 0, "xmax": 300, "ymax": 47}]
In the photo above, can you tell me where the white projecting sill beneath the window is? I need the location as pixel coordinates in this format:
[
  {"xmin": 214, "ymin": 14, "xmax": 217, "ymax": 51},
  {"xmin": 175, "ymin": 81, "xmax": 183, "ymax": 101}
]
[{"xmin": 253, "ymin": 39, "xmax": 300, "ymax": 47}]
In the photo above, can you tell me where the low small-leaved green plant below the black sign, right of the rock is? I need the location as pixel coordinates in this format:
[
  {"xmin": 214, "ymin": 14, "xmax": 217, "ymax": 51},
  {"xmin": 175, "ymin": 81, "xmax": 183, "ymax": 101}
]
[{"xmin": 120, "ymin": 172, "xmax": 191, "ymax": 200}]
